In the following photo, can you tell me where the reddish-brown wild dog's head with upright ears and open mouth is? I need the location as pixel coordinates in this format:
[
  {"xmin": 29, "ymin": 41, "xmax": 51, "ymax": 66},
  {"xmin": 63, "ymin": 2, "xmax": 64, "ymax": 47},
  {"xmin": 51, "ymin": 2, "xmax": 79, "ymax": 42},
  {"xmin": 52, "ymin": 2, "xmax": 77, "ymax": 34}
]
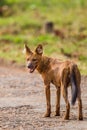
[{"xmin": 24, "ymin": 44, "xmax": 43, "ymax": 73}]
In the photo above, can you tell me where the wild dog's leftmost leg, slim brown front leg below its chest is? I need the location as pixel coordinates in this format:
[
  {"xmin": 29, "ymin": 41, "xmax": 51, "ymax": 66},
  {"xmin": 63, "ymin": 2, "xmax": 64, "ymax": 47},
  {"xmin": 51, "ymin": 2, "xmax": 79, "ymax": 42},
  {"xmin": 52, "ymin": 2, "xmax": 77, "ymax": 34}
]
[{"xmin": 44, "ymin": 85, "xmax": 51, "ymax": 117}]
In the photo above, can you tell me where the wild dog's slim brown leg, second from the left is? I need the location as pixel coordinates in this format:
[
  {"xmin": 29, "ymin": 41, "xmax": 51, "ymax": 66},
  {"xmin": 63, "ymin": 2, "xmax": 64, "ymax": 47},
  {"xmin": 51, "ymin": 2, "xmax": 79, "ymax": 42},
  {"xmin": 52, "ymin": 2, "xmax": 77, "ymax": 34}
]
[{"xmin": 55, "ymin": 87, "xmax": 60, "ymax": 116}]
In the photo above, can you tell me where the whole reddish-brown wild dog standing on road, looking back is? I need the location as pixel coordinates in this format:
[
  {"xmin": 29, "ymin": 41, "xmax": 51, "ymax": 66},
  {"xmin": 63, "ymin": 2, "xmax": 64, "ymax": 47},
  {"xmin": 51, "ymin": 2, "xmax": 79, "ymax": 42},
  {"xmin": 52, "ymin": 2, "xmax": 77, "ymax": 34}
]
[{"xmin": 24, "ymin": 45, "xmax": 83, "ymax": 120}]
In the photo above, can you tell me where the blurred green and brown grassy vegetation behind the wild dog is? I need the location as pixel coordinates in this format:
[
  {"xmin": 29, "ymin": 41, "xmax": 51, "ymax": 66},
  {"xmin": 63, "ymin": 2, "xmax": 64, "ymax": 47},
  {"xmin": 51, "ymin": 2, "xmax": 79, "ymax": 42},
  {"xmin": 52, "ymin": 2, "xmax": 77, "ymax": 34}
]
[{"xmin": 0, "ymin": 0, "xmax": 87, "ymax": 75}]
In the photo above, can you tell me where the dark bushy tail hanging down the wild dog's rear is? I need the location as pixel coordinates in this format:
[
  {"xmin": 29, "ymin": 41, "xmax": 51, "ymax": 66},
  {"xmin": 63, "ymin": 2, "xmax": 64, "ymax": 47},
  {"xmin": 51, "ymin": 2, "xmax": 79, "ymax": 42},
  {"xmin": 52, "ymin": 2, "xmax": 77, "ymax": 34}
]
[{"xmin": 70, "ymin": 66, "xmax": 78, "ymax": 105}]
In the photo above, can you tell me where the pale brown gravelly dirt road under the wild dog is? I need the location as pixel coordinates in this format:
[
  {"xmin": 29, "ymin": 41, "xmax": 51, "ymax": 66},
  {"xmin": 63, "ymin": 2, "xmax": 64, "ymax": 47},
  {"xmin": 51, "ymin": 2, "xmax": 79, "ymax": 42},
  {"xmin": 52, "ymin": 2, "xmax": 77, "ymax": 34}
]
[{"xmin": 0, "ymin": 66, "xmax": 87, "ymax": 130}]
